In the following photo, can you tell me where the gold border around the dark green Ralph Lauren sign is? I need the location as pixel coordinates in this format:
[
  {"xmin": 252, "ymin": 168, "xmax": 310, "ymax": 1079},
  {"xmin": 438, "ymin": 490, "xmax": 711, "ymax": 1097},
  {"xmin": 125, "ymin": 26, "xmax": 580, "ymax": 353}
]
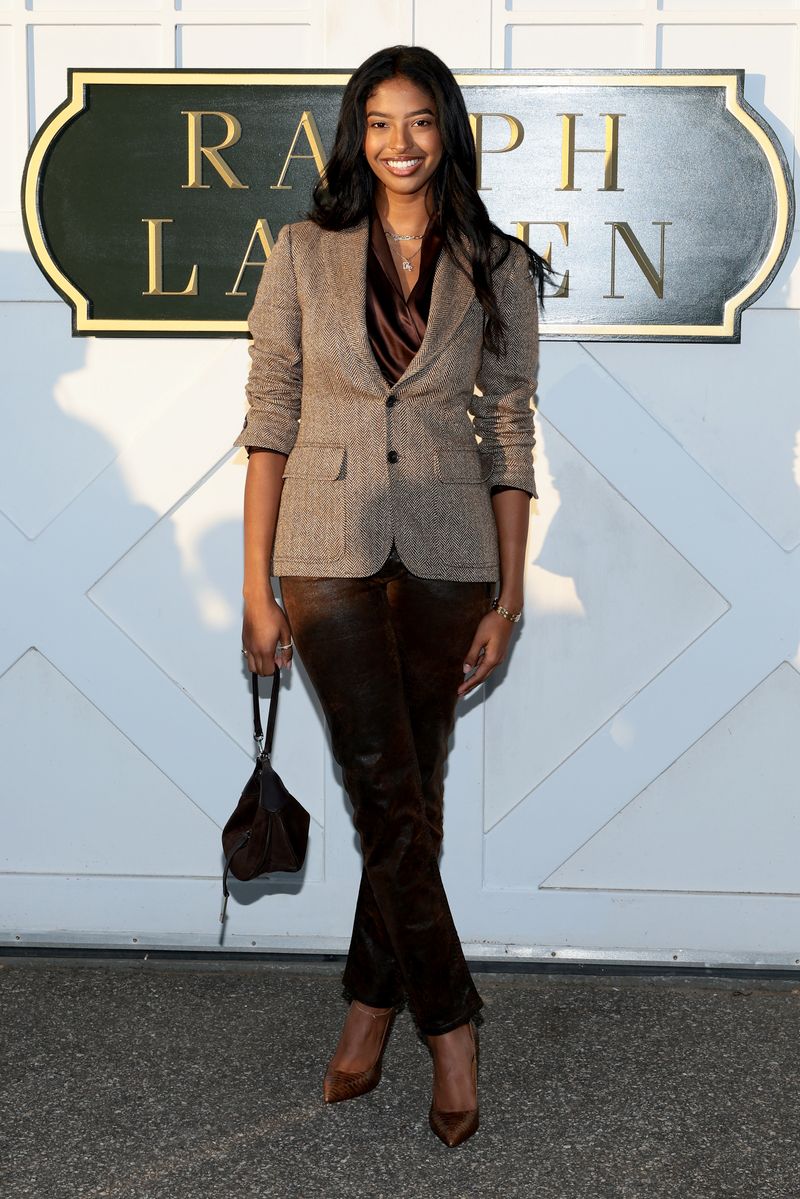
[{"xmin": 23, "ymin": 71, "xmax": 789, "ymax": 339}]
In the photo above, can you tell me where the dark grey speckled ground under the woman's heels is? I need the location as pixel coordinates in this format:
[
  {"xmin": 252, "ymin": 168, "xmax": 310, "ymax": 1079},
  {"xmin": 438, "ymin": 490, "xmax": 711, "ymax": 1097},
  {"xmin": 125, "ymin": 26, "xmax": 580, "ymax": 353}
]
[{"xmin": 0, "ymin": 956, "xmax": 800, "ymax": 1199}]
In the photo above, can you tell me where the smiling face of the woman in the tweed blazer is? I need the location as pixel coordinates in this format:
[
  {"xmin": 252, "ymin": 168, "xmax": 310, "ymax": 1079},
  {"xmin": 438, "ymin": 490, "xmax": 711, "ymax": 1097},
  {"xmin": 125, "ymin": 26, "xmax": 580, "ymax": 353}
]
[{"xmin": 363, "ymin": 76, "xmax": 443, "ymax": 195}]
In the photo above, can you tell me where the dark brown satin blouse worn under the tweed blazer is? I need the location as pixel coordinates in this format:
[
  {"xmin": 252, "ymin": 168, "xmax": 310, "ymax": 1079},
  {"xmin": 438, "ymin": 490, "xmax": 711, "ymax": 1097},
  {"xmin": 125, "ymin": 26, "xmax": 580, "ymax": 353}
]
[{"xmin": 366, "ymin": 204, "xmax": 530, "ymax": 496}]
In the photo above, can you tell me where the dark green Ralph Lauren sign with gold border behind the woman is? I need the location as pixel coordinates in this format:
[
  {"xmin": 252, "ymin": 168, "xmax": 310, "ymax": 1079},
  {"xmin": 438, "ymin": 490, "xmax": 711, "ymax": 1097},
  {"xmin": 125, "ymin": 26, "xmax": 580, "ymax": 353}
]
[{"xmin": 23, "ymin": 70, "xmax": 794, "ymax": 342}]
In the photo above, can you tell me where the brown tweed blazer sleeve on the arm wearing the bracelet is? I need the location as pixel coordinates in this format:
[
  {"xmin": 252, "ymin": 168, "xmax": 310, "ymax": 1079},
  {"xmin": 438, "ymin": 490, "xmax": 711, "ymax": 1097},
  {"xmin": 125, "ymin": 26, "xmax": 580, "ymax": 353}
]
[{"xmin": 470, "ymin": 246, "xmax": 539, "ymax": 499}]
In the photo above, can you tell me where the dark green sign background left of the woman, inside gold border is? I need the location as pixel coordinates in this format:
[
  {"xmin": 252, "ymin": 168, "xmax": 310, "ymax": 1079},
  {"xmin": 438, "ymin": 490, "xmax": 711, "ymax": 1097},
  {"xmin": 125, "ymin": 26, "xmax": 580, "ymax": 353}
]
[{"xmin": 40, "ymin": 85, "xmax": 341, "ymax": 320}]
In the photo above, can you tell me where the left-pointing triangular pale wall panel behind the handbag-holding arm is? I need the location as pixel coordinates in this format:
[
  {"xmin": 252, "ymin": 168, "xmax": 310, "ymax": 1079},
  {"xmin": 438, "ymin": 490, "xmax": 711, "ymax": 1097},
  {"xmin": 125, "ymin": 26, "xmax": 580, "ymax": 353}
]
[{"xmin": 89, "ymin": 458, "xmax": 325, "ymax": 825}]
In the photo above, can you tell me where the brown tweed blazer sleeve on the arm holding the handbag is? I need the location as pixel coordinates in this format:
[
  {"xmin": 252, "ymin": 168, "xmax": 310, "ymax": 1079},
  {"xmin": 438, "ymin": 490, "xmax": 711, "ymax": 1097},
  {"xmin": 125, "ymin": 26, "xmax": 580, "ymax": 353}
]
[{"xmin": 233, "ymin": 225, "xmax": 302, "ymax": 457}]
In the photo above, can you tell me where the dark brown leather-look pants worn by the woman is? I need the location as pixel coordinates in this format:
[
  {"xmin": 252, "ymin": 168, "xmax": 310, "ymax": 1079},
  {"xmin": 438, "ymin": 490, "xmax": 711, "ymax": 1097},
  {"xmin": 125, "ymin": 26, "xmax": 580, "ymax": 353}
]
[{"xmin": 279, "ymin": 546, "xmax": 495, "ymax": 1035}]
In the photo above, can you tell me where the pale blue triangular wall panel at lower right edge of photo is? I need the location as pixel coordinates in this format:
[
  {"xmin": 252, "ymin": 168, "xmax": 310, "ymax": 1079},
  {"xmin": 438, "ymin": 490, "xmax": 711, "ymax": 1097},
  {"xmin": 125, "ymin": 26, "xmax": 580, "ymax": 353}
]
[{"xmin": 540, "ymin": 662, "xmax": 800, "ymax": 894}]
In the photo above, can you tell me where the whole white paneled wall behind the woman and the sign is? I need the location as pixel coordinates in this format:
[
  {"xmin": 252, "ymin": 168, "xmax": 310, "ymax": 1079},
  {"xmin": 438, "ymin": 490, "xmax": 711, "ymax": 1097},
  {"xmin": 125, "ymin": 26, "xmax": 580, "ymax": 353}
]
[{"xmin": 0, "ymin": 0, "xmax": 800, "ymax": 965}]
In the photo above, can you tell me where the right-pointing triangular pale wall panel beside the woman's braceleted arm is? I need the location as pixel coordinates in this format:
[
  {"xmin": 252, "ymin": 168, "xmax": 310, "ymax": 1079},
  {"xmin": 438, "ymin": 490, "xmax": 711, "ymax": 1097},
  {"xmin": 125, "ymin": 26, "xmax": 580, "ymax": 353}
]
[{"xmin": 483, "ymin": 422, "xmax": 727, "ymax": 831}]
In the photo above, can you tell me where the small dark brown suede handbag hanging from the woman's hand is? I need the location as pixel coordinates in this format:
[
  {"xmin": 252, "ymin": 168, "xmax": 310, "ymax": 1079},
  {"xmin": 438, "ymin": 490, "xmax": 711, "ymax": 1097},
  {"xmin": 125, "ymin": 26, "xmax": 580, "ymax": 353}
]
[{"xmin": 219, "ymin": 663, "xmax": 311, "ymax": 923}]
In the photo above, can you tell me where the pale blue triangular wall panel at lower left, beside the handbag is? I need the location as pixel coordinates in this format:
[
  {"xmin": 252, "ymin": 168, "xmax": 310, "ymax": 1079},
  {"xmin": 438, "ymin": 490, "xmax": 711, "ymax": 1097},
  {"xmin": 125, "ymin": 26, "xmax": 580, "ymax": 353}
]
[{"xmin": 0, "ymin": 649, "xmax": 221, "ymax": 877}]
